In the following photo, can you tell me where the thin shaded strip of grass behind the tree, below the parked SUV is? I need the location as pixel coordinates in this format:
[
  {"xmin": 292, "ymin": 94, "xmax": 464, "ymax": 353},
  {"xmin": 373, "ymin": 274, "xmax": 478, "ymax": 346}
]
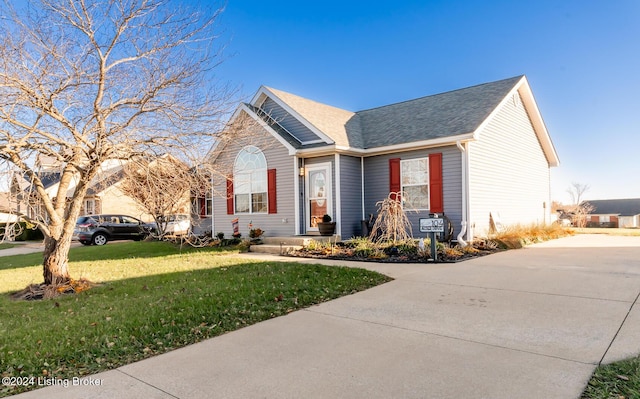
[{"xmin": 0, "ymin": 241, "xmax": 234, "ymax": 270}]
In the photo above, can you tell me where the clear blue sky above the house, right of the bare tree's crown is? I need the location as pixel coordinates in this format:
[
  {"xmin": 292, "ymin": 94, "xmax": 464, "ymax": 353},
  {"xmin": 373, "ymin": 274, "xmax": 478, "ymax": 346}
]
[{"xmin": 211, "ymin": 0, "xmax": 640, "ymax": 202}]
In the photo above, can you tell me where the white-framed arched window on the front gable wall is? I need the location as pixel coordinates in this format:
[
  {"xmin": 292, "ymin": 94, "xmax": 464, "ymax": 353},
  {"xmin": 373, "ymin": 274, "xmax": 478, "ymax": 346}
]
[{"xmin": 233, "ymin": 145, "xmax": 267, "ymax": 213}]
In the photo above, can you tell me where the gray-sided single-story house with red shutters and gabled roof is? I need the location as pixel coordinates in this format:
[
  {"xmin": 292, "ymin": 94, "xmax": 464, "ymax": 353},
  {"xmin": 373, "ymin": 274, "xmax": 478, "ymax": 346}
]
[{"xmin": 212, "ymin": 76, "xmax": 559, "ymax": 240}]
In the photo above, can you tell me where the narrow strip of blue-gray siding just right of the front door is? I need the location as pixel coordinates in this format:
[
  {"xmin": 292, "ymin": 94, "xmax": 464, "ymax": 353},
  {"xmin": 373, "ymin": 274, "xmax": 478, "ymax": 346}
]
[{"xmin": 340, "ymin": 155, "xmax": 362, "ymax": 239}]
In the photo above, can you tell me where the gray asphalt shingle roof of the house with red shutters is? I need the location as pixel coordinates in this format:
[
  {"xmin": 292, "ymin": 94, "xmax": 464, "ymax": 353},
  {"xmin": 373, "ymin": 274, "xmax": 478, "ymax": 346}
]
[{"xmin": 268, "ymin": 76, "xmax": 523, "ymax": 149}]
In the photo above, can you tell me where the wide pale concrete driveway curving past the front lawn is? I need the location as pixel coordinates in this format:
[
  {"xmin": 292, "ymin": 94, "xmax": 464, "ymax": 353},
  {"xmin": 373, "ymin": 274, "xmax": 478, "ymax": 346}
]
[{"xmin": 11, "ymin": 235, "xmax": 640, "ymax": 399}]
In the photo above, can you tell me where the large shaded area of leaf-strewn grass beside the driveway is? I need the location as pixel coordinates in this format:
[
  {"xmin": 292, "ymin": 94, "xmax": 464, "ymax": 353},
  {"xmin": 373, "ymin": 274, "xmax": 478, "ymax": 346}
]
[{"xmin": 0, "ymin": 257, "xmax": 391, "ymax": 396}]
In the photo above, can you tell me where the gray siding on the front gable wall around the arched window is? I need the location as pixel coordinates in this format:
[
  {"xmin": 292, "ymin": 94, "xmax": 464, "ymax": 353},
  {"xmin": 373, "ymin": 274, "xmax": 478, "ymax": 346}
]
[{"xmin": 213, "ymin": 122, "xmax": 297, "ymax": 237}]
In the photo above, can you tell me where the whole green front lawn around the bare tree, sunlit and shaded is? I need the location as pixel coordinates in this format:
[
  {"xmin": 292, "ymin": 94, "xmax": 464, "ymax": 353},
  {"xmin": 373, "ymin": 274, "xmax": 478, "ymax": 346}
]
[{"xmin": 0, "ymin": 242, "xmax": 390, "ymax": 396}]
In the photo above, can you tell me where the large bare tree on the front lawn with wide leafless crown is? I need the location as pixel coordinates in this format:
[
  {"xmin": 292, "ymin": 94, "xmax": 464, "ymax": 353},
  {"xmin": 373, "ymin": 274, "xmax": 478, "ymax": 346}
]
[{"xmin": 0, "ymin": 0, "xmax": 232, "ymax": 285}]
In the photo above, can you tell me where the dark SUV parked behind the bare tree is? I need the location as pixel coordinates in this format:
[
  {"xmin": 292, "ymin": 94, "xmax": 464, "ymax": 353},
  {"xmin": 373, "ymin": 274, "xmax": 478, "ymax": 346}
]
[{"xmin": 73, "ymin": 215, "xmax": 152, "ymax": 245}]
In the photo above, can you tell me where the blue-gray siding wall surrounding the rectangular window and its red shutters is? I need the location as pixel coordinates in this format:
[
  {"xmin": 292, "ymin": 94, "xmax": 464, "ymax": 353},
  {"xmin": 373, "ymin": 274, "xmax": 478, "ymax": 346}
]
[{"xmin": 364, "ymin": 146, "xmax": 462, "ymax": 237}]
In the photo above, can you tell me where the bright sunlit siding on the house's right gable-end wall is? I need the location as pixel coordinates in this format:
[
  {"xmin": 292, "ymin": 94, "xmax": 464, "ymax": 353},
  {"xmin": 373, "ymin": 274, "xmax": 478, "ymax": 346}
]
[{"xmin": 469, "ymin": 92, "xmax": 550, "ymax": 236}]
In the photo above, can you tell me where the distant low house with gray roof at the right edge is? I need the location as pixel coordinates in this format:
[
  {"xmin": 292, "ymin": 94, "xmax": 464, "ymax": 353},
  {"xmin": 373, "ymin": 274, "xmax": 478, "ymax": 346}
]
[{"xmin": 585, "ymin": 198, "xmax": 640, "ymax": 228}]
